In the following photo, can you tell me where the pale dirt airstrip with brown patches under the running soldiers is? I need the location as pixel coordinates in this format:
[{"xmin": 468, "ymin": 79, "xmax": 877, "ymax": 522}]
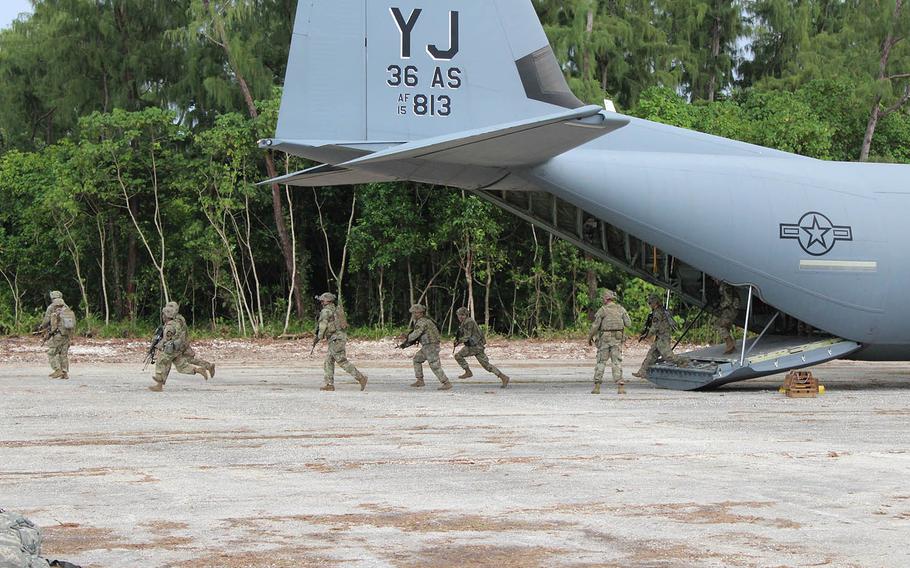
[{"xmin": 0, "ymin": 339, "xmax": 910, "ymax": 568}]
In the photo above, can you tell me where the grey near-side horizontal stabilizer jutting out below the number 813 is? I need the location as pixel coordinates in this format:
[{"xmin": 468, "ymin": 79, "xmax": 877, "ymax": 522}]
[{"xmin": 342, "ymin": 106, "xmax": 629, "ymax": 168}]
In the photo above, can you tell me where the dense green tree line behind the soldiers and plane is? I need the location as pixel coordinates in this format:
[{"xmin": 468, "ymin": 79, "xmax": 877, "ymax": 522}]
[{"xmin": 0, "ymin": 0, "xmax": 910, "ymax": 336}]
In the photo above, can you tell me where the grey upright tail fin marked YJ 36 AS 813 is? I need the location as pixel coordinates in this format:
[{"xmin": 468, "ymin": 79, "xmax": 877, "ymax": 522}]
[{"xmin": 276, "ymin": 0, "xmax": 584, "ymax": 153}]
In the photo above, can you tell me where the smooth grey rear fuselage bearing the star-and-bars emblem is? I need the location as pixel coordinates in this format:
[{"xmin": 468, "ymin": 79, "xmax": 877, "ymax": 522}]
[{"xmin": 525, "ymin": 115, "xmax": 910, "ymax": 359}]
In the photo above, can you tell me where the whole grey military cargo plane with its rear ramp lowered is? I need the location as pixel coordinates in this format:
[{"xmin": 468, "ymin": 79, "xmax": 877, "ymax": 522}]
[{"xmin": 260, "ymin": 0, "xmax": 910, "ymax": 390}]
